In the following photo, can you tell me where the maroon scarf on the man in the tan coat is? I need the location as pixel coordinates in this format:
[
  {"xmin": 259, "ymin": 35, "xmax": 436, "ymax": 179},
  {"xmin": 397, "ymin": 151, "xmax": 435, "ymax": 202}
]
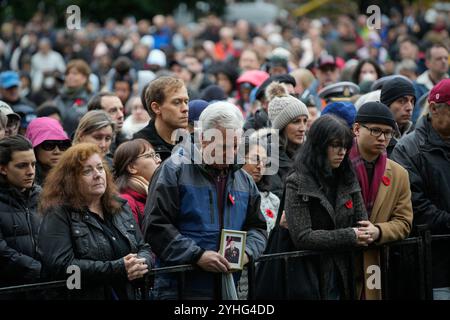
[{"xmin": 349, "ymin": 138, "xmax": 387, "ymax": 217}]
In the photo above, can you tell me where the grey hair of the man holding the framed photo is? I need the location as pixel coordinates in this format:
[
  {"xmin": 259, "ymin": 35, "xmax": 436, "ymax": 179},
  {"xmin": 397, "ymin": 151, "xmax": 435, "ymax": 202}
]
[{"xmin": 199, "ymin": 101, "xmax": 244, "ymax": 131}]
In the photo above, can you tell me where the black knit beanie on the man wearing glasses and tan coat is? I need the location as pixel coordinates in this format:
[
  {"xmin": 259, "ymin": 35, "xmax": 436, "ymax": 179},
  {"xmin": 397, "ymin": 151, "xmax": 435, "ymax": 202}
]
[{"xmin": 355, "ymin": 102, "xmax": 396, "ymax": 129}]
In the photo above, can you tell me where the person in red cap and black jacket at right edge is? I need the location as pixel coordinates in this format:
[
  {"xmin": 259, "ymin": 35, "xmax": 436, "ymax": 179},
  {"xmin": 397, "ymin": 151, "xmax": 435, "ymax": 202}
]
[{"xmin": 392, "ymin": 79, "xmax": 450, "ymax": 299}]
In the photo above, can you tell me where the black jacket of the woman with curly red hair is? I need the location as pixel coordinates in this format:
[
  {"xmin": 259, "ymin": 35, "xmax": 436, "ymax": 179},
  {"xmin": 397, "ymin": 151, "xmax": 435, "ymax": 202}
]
[{"xmin": 38, "ymin": 202, "xmax": 153, "ymax": 300}]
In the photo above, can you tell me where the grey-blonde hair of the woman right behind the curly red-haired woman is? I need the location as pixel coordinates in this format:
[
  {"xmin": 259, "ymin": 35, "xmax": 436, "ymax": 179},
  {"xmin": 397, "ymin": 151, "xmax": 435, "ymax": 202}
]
[{"xmin": 73, "ymin": 110, "xmax": 116, "ymax": 144}]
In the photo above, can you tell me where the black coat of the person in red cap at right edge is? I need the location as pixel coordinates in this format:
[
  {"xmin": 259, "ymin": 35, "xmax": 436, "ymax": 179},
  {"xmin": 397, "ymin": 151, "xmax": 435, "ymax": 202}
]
[{"xmin": 391, "ymin": 117, "xmax": 450, "ymax": 288}]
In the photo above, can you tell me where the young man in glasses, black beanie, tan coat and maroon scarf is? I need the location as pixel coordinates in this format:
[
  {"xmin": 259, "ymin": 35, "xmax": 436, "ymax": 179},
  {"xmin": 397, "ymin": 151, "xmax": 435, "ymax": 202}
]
[{"xmin": 350, "ymin": 102, "xmax": 413, "ymax": 300}]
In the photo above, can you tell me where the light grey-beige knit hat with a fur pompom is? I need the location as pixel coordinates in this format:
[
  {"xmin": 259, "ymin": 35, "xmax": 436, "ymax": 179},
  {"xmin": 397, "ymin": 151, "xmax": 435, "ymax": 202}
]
[{"xmin": 266, "ymin": 82, "xmax": 309, "ymax": 130}]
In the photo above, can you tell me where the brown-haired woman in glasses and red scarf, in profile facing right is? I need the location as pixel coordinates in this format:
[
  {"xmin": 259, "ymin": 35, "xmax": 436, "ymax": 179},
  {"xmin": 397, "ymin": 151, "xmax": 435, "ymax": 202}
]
[{"xmin": 114, "ymin": 139, "xmax": 161, "ymax": 226}]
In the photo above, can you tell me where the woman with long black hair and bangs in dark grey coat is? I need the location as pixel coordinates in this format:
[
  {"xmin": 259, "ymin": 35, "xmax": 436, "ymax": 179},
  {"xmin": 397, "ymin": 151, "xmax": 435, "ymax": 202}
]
[{"xmin": 285, "ymin": 115, "xmax": 370, "ymax": 300}]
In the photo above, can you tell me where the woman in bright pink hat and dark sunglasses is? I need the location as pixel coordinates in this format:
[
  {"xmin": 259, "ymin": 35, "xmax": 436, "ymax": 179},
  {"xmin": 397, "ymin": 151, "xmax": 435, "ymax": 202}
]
[{"xmin": 25, "ymin": 117, "xmax": 72, "ymax": 185}]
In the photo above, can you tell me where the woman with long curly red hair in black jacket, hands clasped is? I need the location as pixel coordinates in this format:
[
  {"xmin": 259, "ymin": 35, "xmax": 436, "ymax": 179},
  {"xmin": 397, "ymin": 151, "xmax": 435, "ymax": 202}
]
[{"xmin": 38, "ymin": 143, "xmax": 152, "ymax": 300}]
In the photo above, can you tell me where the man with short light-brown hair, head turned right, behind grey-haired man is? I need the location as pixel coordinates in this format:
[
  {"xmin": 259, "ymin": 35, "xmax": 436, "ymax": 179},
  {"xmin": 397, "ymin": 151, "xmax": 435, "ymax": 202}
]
[{"xmin": 133, "ymin": 76, "xmax": 189, "ymax": 161}]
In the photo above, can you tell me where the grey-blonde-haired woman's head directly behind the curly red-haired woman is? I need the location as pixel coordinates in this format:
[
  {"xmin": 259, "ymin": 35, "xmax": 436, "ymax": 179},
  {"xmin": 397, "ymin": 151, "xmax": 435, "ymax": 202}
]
[{"xmin": 73, "ymin": 110, "xmax": 116, "ymax": 168}]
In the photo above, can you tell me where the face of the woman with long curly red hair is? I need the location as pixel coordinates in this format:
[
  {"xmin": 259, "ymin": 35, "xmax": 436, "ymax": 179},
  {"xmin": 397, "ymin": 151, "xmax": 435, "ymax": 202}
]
[{"xmin": 80, "ymin": 153, "xmax": 106, "ymax": 201}]
